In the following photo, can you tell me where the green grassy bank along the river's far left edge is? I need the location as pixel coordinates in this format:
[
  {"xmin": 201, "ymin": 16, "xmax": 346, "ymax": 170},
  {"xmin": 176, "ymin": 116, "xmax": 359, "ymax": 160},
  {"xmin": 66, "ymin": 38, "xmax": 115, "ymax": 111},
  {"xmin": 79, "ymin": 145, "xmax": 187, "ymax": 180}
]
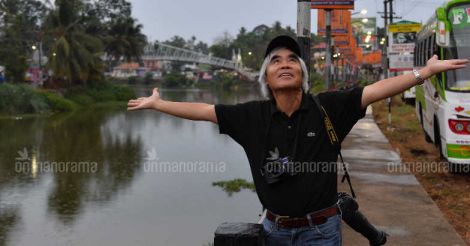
[{"xmin": 0, "ymin": 83, "xmax": 135, "ymax": 116}]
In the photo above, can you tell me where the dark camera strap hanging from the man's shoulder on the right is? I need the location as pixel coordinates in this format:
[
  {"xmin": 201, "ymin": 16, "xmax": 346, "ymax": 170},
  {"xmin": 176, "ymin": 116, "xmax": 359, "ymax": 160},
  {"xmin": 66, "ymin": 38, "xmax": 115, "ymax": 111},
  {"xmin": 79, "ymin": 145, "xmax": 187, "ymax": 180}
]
[{"xmin": 312, "ymin": 95, "xmax": 356, "ymax": 198}]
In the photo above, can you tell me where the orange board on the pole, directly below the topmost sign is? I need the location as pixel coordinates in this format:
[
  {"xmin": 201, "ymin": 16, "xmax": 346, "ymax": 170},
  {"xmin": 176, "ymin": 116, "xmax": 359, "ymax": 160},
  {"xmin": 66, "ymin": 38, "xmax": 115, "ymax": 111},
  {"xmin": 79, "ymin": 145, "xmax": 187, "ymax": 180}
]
[{"xmin": 317, "ymin": 9, "xmax": 351, "ymax": 36}]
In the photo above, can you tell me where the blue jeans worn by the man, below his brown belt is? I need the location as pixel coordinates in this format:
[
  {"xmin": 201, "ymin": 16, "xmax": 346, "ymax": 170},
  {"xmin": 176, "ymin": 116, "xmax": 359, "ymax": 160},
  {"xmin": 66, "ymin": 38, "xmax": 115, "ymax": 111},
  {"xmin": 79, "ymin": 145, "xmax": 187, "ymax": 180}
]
[{"xmin": 263, "ymin": 214, "xmax": 341, "ymax": 246}]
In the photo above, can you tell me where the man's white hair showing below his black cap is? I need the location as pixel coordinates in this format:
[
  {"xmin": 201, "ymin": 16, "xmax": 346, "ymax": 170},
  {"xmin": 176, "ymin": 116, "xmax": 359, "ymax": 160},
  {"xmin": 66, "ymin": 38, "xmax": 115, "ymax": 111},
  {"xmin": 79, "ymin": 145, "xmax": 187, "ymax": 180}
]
[{"xmin": 258, "ymin": 47, "xmax": 309, "ymax": 99}]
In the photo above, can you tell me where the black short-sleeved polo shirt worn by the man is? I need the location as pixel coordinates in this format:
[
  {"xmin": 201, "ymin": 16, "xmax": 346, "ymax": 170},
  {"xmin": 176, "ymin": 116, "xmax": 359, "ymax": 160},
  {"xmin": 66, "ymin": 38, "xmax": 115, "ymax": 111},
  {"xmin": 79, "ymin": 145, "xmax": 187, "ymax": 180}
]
[{"xmin": 215, "ymin": 87, "xmax": 365, "ymax": 217}]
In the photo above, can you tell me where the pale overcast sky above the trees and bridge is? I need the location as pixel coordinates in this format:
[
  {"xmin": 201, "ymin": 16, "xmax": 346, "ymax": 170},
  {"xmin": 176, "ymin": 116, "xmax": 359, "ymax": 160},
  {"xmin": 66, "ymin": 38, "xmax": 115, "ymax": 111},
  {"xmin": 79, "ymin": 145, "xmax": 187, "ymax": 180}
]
[{"xmin": 129, "ymin": 0, "xmax": 444, "ymax": 44}]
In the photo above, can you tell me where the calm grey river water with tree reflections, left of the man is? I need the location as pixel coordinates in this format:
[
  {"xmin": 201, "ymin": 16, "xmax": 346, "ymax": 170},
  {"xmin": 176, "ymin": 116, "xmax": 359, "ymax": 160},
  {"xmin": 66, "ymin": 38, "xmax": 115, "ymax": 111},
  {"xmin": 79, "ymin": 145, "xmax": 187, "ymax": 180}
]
[{"xmin": 0, "ymin": 87, "xmax": 259, "ymax": 246}]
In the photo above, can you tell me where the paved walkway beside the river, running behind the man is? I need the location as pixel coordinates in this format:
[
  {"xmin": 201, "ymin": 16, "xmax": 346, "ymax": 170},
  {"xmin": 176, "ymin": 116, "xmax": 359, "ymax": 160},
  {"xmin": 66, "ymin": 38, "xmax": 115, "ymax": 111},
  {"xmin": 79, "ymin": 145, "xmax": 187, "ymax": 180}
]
[{"xmin": 338, "ymin": 107, "xmax": 466, "ymax": 246}]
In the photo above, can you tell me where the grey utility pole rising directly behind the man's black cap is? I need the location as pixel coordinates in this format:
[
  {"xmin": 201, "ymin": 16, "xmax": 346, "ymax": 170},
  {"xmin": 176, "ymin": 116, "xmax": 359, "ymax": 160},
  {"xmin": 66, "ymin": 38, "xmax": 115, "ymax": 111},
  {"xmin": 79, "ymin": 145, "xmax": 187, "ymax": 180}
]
[{"xmin": 297, "ymin": 0, "xmax": 312, "ymax": 79}]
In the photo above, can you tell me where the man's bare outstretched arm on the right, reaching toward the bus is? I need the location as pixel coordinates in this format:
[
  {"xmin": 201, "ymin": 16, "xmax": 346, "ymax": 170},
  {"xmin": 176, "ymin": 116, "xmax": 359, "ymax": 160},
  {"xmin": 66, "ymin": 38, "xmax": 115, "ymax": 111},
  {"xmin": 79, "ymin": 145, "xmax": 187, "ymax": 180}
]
[{"xmin": 362, "ymin": 55, "xmax": 468, "ymax": 108}]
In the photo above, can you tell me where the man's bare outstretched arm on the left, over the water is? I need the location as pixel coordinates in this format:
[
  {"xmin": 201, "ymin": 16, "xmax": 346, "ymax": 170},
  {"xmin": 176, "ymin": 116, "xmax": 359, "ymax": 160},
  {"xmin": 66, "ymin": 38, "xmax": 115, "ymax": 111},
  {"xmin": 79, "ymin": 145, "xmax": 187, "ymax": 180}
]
[{"xmin": 127, "ymin": 88, "xmax": 217, "ymax": 124}]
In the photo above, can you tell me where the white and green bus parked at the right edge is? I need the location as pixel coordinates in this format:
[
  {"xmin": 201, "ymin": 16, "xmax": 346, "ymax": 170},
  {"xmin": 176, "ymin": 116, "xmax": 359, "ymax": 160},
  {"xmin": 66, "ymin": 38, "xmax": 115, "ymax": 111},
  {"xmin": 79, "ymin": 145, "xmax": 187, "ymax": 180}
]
[{"xmin": 414, "ymin": 0, "xmax": 470, "ymax": 172}]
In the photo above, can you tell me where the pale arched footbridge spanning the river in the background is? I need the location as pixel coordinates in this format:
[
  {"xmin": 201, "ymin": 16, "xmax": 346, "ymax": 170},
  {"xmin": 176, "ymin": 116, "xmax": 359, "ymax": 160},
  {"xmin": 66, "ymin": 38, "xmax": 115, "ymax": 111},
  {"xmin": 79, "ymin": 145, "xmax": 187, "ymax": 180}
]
[{"xmin": 142, "ymin": 43, "xmax": 258, "ymax": 81}]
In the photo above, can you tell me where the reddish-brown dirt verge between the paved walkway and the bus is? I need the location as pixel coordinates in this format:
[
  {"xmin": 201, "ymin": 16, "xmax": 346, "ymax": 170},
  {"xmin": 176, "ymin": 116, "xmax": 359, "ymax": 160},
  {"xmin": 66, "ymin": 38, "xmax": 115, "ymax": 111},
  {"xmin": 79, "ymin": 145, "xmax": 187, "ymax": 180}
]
[{"xmin": 373, "ymin": 96, "xmax": 470, "ymax": 245}]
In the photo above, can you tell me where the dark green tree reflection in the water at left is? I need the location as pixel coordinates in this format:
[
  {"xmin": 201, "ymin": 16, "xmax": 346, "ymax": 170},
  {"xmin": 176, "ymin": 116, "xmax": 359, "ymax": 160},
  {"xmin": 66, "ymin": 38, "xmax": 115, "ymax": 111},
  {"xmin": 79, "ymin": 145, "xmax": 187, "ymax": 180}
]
[{"xmin": 0, "ymin": 109, "xmax": 141, "ymax": 224}]
